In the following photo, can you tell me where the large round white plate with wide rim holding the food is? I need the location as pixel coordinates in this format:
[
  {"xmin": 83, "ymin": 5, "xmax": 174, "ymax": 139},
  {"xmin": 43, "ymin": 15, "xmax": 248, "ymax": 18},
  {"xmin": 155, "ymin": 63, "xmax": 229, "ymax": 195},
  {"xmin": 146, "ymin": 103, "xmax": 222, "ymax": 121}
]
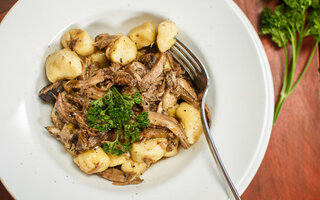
[{"xmin": 0, "ymin": 0, "xmax": 273, "ymax": 200}]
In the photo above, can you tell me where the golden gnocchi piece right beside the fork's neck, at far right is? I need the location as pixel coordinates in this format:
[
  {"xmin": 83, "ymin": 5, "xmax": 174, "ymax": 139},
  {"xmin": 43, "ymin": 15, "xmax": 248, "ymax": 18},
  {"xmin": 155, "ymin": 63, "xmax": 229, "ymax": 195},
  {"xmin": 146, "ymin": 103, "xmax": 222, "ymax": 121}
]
[{"xmin": 176, "ymin": 102, "xmax": 203, "ymax": 144}]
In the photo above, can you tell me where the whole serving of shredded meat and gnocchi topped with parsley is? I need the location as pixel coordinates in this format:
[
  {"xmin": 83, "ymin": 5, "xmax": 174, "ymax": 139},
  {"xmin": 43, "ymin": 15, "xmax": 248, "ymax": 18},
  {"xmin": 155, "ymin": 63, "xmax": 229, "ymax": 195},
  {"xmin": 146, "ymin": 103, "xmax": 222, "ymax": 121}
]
[{"xmin": 39, "ymin": 20, "xmax": 210, "ymax": 185}]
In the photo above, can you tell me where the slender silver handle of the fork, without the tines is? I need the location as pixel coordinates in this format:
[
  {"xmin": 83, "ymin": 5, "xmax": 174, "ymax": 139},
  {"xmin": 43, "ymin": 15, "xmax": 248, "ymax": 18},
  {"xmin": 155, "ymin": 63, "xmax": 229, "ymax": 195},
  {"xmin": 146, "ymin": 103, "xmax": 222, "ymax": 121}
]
[{"xmin": 201, "ymin": 101, "xmax": 241, "ymax": 200}]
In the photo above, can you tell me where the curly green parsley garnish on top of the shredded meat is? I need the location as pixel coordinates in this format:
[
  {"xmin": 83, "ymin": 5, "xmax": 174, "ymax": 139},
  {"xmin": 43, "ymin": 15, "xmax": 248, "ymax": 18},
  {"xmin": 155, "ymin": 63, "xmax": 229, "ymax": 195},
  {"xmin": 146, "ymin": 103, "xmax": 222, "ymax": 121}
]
[{"xmin": 87, "ymin": 87, "xmax": 150, "ymax": 155}]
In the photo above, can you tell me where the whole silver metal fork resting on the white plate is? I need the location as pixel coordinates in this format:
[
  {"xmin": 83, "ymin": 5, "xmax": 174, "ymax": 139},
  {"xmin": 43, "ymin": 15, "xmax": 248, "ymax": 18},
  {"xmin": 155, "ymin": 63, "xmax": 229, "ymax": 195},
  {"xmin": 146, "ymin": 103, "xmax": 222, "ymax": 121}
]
[{"xmin": 169, "ymin": 39, "xmax": 241, "ymax": 200}]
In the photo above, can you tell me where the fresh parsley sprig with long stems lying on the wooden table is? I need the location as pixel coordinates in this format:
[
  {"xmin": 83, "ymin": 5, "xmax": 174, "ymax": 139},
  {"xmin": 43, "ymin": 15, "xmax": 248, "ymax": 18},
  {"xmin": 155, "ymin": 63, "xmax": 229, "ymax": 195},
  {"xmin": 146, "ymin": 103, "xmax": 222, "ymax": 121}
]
[{"xmin": 260, "ymin": 0, "xmax": 320, "ymax": 124}]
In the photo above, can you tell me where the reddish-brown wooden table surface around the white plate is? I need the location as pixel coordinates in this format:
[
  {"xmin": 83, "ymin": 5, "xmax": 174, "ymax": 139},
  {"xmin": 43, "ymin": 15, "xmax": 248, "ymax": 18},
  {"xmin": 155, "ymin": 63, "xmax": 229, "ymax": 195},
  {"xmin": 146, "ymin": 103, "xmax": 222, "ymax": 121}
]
[{"xmin": 0, "ymin": 0, "xmax": 320, "ymax": 200}]
